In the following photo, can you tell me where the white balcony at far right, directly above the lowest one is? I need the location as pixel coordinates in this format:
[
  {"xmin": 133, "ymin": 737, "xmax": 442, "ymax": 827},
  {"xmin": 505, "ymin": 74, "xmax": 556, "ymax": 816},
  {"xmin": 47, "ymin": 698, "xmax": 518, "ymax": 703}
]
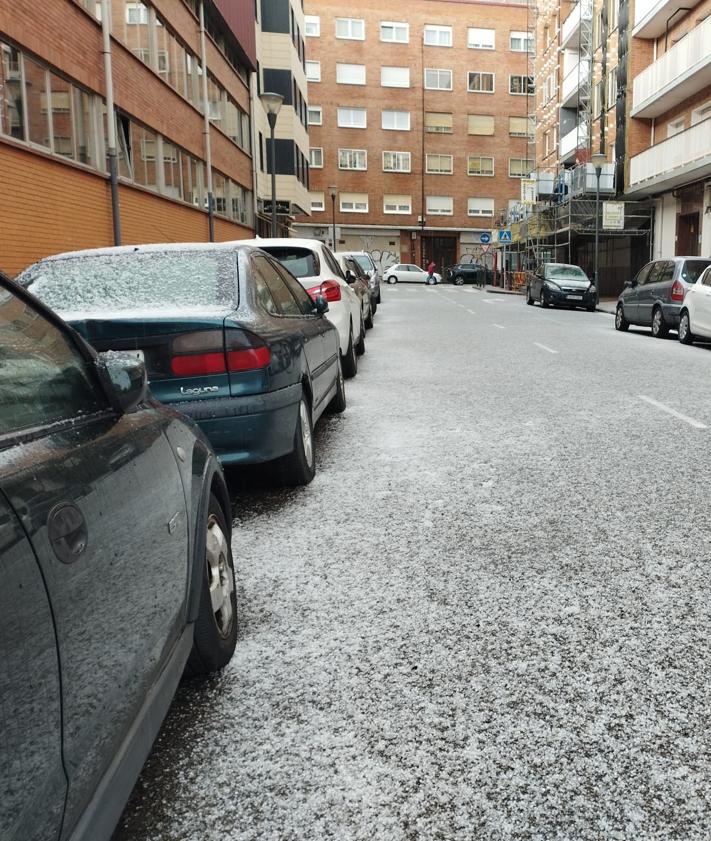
[{"xmin": 632, "ymin": 17, "xmax": 711, "ymax": 118}]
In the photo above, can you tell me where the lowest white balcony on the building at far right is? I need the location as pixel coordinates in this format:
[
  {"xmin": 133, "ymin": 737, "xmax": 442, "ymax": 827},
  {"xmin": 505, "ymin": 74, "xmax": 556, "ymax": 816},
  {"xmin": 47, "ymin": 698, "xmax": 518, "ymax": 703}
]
[{"xmin": 626, "ymin": 117, "xmax": 711, "ymax": 194}]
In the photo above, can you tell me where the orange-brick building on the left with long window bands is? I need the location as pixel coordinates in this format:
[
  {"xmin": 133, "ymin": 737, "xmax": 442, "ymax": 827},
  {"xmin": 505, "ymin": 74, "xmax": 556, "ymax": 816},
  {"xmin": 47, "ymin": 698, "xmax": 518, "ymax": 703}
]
[{"xmin": 0, "ymin": 0, "xmax": 256, "ymax": 275}]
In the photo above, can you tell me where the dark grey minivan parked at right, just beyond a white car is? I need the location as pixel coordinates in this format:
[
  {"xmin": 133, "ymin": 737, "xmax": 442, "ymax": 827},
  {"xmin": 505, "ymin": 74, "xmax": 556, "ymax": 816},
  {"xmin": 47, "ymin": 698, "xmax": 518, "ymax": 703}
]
[{"xmin": 615, "ymin": 257, "xmax": 711, "ymax": 339}]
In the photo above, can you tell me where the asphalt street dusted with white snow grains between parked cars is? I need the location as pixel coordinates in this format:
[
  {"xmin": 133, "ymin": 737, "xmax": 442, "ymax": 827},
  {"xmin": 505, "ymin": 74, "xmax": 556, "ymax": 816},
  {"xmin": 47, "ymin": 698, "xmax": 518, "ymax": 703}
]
[{"xmin": 115, "ymin": 286, "xmax": 711, "ymax": 841}]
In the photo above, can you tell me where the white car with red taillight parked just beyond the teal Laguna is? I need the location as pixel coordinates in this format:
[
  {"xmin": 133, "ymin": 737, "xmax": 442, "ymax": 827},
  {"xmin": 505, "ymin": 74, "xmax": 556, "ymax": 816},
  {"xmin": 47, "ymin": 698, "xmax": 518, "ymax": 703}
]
[{"xmin": 239, "ymin": 238, "xmax": 365, "ymax": 377}]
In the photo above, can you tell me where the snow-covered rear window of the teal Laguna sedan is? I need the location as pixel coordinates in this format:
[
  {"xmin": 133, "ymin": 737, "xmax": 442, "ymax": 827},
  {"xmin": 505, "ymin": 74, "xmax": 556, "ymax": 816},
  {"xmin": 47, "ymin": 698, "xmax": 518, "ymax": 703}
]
[{"xmin": 23, "ymin": 251, "xmax": 236, "ymax": 312}]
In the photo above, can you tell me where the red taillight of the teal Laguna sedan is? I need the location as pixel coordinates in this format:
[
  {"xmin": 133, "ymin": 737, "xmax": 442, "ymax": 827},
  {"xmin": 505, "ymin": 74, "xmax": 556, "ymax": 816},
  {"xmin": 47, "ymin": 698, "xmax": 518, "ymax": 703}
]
[{"xmin": 170, "ymin": 328, "xmax": 271, "ymax": 377}]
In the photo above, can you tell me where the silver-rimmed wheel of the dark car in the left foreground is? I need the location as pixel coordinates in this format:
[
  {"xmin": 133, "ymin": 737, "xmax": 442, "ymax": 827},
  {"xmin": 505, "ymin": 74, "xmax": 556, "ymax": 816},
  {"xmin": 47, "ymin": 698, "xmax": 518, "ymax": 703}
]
[{"xmin": 185, "ymin": 494, "xmax": 237, "ymax": 677}]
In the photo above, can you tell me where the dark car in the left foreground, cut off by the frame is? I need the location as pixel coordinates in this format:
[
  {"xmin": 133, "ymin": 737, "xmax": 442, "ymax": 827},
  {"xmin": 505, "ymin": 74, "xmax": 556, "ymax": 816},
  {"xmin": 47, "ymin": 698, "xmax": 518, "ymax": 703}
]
[{"xmin": 0, "ymin": 270, "xmax": 237, "ymax": 841}]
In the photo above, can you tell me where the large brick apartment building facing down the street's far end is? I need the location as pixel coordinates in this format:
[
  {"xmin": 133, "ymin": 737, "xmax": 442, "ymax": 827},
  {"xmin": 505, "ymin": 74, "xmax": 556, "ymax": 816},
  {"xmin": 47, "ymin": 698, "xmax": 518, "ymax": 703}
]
[{"xmin": 295, "ymin": 0, "xmax": 533, "ymax": 267}]
